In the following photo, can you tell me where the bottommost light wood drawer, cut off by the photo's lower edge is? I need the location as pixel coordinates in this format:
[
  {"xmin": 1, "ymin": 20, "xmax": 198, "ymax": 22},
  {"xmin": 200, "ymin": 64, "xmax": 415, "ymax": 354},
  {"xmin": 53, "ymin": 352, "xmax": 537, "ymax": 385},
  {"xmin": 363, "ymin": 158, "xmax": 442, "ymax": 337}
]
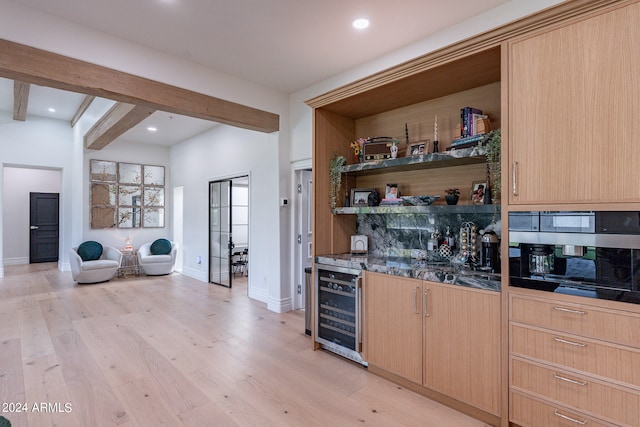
[{"xmin": 509, "ymin": 392, "xmax": 611, "ymax": 427}]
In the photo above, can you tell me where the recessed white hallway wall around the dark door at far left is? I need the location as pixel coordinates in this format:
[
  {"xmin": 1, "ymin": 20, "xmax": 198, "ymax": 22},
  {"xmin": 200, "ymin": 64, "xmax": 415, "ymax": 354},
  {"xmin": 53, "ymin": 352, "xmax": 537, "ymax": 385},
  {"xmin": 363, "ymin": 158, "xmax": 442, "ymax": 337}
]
[{"xmin": 2, "ymin": 166, "xmax": 62, "ymax": 265}]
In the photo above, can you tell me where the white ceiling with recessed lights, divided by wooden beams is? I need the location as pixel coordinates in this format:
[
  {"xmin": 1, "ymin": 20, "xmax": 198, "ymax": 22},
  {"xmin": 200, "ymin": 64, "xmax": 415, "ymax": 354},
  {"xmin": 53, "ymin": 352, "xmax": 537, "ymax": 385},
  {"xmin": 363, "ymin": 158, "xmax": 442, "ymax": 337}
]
[{"xmin": 0, "ymin": 0, "xmax": 510, "ymax": 145}]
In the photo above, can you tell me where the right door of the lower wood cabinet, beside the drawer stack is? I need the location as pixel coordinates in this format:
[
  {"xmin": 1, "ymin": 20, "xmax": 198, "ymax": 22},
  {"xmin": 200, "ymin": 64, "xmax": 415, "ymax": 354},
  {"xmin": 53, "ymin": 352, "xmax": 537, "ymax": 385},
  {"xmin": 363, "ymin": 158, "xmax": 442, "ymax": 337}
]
[{"xmin": 423, "ymin": 282, "xmax": 500, "ymax": 415}]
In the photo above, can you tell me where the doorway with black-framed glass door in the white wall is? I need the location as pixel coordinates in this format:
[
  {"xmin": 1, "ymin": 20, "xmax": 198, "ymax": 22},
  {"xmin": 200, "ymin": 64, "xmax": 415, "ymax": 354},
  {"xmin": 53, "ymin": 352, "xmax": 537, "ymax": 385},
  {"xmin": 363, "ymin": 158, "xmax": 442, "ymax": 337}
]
[{"xmin": 209, "ymin": 175, "xmax": 250, "ymax": 294}]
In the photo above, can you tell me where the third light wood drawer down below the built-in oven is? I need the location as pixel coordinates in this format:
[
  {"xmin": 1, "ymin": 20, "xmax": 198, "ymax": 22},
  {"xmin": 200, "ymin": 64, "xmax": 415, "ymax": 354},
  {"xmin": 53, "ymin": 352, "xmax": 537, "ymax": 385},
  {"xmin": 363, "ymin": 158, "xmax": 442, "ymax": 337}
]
[{"xmin": 511, "ymin": 358, "xmax": 640, "ymax": 425}]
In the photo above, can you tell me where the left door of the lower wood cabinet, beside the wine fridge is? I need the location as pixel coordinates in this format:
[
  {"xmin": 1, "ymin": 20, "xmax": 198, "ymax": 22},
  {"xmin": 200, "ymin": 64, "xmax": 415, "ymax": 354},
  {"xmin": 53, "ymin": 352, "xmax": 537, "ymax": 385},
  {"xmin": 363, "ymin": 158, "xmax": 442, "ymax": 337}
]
[{"xmin": 364, "ymin": 272, "xmax": 422, "ymax": 383}]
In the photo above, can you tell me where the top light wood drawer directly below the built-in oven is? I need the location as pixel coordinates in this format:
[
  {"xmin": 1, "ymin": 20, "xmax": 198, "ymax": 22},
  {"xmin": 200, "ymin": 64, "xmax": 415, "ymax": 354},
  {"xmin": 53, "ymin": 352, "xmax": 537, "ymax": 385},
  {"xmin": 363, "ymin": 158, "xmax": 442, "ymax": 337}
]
[{"xmin": 509, "ymin": 294, "xmax": 640, "ymax": 347}]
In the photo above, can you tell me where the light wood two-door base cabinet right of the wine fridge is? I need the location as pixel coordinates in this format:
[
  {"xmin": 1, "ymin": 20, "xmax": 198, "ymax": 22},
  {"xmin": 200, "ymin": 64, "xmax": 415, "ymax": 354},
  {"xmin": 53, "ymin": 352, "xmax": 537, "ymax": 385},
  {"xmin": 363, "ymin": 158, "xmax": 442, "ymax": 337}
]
[{"xmin": 364, "ymin": 272, "xmax": 501, "ymax": 415}]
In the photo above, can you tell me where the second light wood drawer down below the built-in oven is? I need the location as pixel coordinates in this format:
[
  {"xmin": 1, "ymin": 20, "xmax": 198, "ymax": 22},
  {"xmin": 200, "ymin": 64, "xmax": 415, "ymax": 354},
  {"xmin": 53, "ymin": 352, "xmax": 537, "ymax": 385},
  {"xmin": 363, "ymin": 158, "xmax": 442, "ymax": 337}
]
[{"xmin": 509, "ymin": 323, "xmax": 640, "ymax": 388}]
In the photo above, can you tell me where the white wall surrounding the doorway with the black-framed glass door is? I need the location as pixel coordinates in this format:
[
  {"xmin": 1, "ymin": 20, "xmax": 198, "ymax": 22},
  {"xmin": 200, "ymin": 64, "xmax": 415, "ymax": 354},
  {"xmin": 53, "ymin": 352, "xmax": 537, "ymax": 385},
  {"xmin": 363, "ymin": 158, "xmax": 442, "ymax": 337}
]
[{"xmin": 171, "ymin": 126, "xmax": 291, "ymax": 312}]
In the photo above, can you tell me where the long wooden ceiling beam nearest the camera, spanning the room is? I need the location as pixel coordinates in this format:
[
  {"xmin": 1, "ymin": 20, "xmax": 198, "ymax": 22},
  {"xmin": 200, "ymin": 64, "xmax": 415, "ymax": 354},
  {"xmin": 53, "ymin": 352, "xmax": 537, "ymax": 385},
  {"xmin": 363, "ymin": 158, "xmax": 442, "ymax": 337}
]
[{"xmin": 0, "ymin": 39, "xmax": 280, "ymax": 133}]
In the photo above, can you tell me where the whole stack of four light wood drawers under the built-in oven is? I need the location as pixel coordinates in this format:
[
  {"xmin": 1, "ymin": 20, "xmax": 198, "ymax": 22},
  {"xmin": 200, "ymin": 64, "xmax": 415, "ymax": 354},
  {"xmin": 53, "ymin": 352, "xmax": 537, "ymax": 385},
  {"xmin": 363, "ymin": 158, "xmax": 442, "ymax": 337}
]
[{"xmin": 509, "ymin": 291, "xmax": 640, "ymax": 426}]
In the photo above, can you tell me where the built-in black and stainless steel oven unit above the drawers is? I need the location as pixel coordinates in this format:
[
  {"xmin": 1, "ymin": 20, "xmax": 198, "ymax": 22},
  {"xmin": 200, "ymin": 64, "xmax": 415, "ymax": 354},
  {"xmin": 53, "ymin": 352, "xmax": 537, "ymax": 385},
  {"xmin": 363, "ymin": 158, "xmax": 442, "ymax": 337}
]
[{"xmin": 509, "ymin": 212, "xmax": 640, "ymax": 304}]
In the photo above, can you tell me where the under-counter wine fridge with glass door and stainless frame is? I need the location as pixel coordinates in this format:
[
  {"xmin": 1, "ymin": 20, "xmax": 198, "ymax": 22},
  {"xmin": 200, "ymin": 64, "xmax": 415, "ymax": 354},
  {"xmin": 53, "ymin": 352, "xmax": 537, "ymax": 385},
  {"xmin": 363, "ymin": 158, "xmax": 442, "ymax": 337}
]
[{"xmin": 314, "ymin": 264, "xmax": 367, "ymax": 366}]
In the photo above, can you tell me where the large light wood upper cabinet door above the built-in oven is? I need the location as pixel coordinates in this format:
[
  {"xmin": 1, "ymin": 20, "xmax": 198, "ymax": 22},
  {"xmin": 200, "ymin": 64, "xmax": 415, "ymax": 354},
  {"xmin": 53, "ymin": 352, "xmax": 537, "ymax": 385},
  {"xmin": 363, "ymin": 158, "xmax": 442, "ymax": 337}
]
[{"xmin": 510, "ymin": 3, "xmax": 640, "ymax": 204}]
